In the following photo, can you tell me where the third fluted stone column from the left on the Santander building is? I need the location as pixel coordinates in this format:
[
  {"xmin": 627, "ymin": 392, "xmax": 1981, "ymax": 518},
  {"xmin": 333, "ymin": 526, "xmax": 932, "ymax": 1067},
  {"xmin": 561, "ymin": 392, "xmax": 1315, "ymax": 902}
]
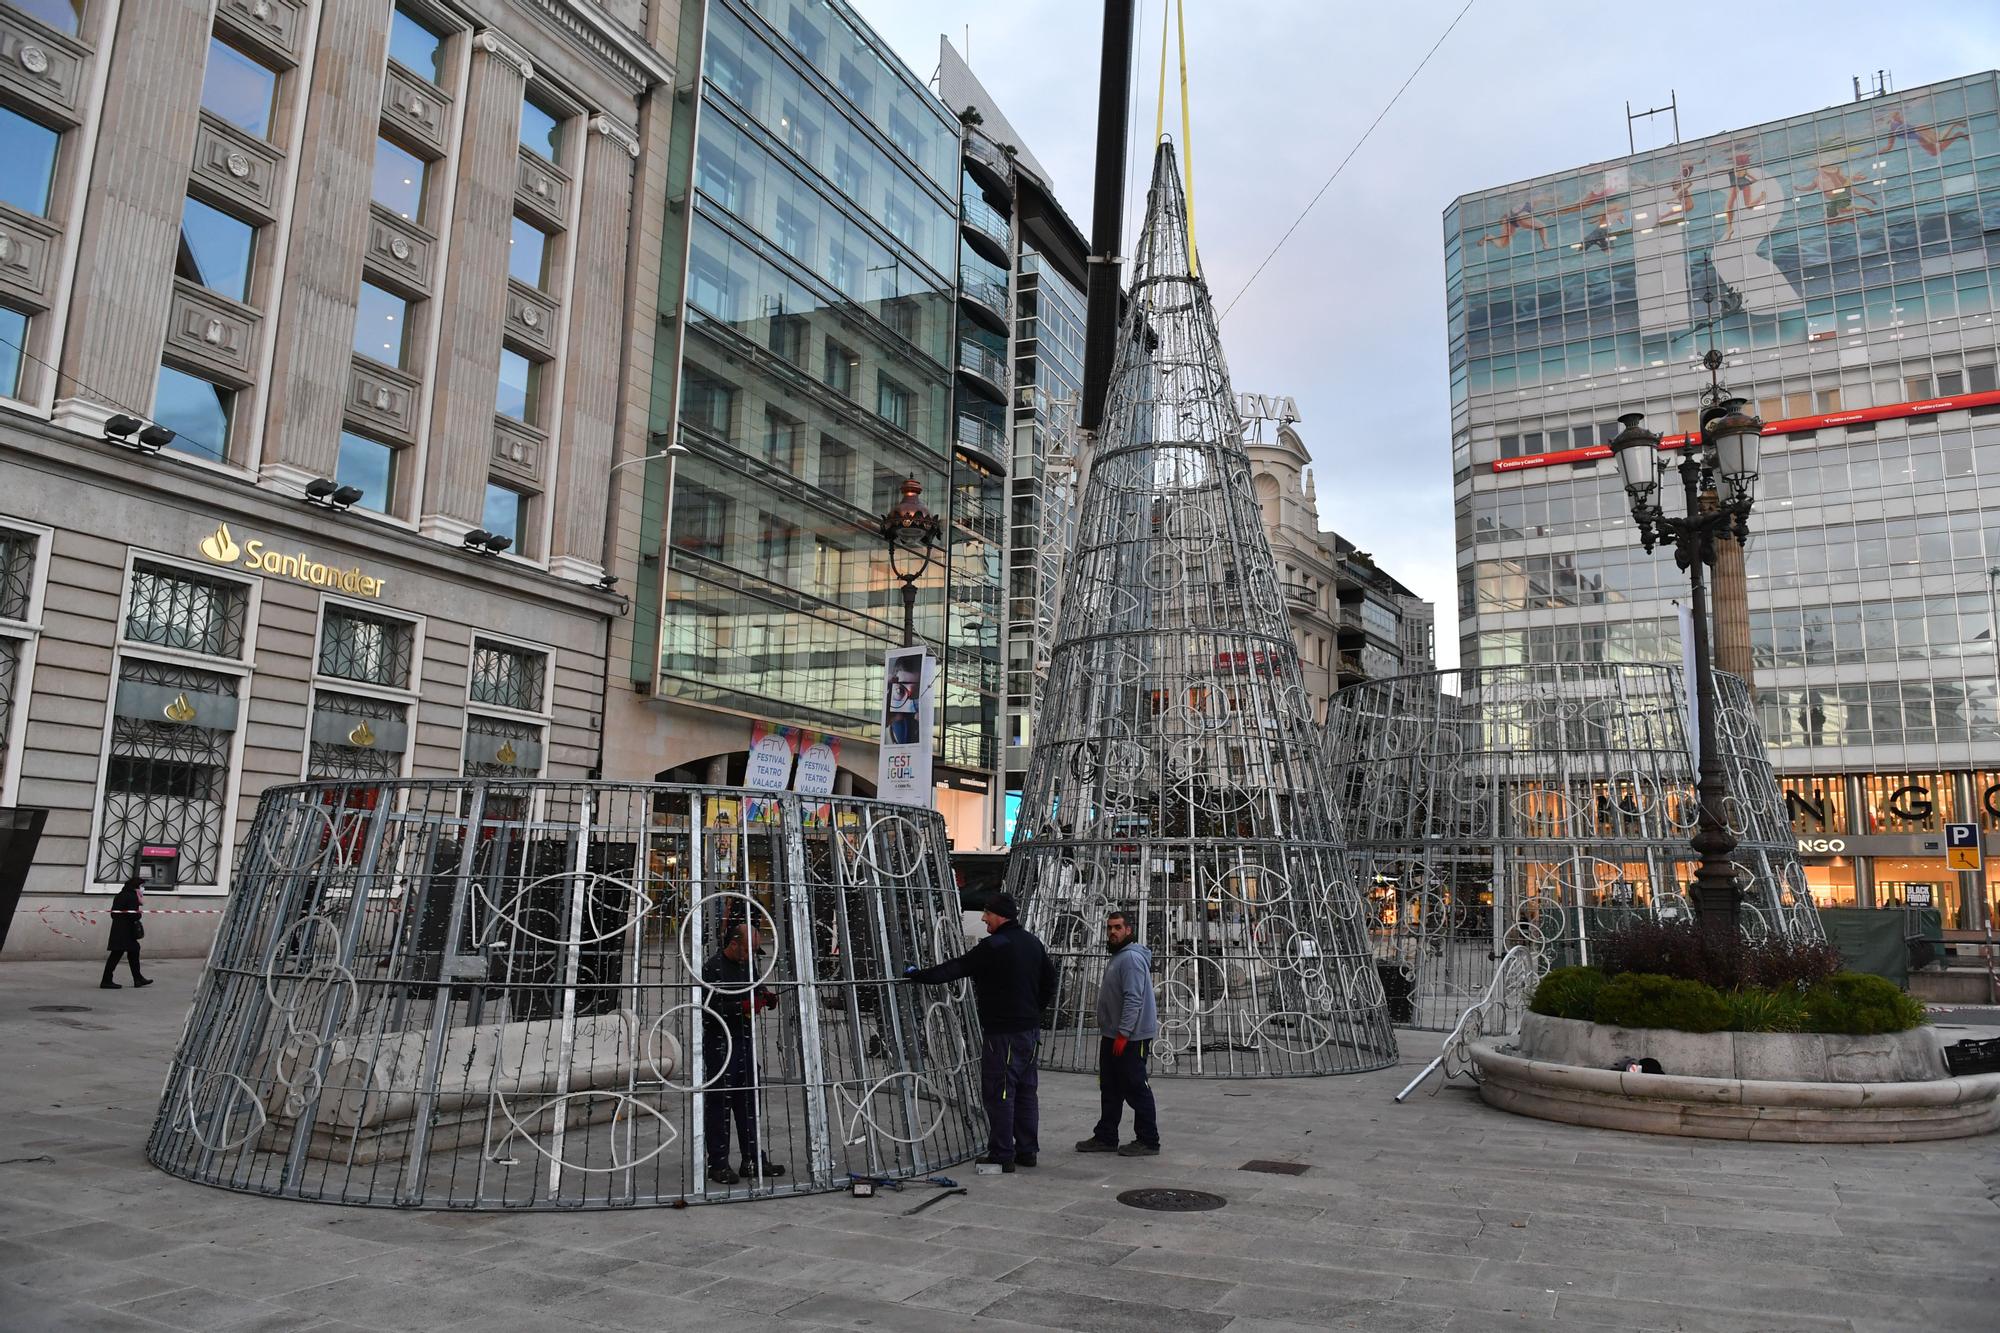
[{"xmin": 422, "ymin": 30, "xmax": 534, "ymax": 540}]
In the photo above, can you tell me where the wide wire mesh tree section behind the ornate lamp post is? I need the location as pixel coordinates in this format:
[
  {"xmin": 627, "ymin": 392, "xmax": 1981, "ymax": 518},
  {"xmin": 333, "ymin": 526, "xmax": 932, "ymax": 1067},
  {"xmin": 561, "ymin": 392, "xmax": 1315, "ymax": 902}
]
[{"xmin": 1326, "ymin": 662, "xmax": 1822, "ymax": 1029}]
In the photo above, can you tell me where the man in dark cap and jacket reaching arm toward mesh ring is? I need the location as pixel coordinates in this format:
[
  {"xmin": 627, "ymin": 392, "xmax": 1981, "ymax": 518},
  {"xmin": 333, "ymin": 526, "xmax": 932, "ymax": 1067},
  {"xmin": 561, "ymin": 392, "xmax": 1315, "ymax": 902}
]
[{"xmin": 902, "ymin": 893, "xmax": 1056, "ymax": 1173}]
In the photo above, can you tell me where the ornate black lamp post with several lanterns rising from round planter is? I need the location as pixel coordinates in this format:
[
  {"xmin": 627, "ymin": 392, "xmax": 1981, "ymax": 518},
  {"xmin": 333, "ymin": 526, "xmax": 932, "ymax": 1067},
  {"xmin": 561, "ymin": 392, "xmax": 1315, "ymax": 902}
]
[{"xmin": 1612, "ymin": 348, "xmax": 1764, "ymax": 939}]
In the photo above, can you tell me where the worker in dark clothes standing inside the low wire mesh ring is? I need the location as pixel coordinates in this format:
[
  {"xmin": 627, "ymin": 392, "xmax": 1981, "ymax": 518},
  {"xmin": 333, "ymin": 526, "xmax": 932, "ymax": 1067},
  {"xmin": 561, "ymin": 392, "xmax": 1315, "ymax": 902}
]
[{"xmin": 702, "ymin": 917, "xmax": 784, "ymax": 1185}]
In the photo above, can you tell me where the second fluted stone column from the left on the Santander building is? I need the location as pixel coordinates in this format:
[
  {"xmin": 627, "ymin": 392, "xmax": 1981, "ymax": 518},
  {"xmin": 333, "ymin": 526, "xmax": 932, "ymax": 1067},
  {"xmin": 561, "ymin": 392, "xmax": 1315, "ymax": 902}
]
[{"xmin": 262, "ymin": 0, "xmax": 388, "ymax": 482}]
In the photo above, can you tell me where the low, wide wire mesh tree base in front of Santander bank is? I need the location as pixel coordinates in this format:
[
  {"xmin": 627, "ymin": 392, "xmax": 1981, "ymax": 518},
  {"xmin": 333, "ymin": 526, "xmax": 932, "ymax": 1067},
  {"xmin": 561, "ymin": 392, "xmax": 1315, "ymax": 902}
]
[{"xmin": 146, "ymin": 781, "xmax": 986, "ymax": 1209}]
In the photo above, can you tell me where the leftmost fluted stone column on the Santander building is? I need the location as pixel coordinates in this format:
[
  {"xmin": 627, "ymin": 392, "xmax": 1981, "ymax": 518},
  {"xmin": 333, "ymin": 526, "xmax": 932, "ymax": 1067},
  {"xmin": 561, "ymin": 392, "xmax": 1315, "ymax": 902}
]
[{"xmin": 56, "ymin": 0, "xmax": 212, "ymax": 422}]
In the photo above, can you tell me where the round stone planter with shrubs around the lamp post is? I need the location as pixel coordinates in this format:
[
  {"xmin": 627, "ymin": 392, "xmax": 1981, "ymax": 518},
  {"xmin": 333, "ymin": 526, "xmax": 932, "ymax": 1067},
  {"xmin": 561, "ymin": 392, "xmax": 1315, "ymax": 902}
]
[{"xmin": 1472, "ymin": 923, "xmax": 2000, "ymax": 1143}]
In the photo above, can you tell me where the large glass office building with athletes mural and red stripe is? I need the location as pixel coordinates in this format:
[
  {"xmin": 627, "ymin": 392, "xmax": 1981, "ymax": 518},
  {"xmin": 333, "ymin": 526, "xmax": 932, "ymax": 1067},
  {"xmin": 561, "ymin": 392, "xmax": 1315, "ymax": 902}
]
[{"xmin": 1444, "ymin": 74, "xmax": 2000, "ymax": 929}]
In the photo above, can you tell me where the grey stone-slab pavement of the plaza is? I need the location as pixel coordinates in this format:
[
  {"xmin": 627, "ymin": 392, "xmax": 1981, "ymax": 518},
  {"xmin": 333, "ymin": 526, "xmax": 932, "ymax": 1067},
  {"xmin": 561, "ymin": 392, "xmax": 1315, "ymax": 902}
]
[{"xmin": 0, "ymin": 961, "xmax": 2000, "ymax": 1333}]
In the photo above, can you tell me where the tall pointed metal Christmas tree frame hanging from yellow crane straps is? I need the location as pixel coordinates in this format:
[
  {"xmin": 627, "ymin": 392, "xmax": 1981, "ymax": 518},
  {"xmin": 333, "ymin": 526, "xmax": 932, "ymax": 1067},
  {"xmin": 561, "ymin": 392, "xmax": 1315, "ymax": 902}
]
[{"xmin": 1008, "ymin": 144, "xmax": 1396, "ymax": 1077}]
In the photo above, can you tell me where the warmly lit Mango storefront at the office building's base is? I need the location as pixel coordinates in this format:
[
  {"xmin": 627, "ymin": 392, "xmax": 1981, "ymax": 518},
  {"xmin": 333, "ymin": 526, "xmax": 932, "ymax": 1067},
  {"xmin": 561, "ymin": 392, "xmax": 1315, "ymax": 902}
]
[{"xmin": 1778, "ymin": 773, "xmax": 2000, "ymax": 931}]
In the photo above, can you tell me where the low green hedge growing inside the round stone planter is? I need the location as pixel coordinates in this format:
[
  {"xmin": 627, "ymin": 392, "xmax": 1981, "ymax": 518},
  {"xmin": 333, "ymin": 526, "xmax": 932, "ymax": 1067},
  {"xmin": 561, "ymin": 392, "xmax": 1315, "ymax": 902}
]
[{"xmin": 1528, "ymin": 967, "xmax": 1930, "ymax": 1037}]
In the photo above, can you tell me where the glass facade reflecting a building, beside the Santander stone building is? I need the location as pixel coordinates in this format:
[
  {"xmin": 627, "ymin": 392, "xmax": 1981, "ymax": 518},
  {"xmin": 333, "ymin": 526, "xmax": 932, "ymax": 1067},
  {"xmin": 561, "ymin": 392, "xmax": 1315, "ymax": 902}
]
[{"xmin": 656, "ymin": 2, "xmax": 972, "ymax": 749}]
